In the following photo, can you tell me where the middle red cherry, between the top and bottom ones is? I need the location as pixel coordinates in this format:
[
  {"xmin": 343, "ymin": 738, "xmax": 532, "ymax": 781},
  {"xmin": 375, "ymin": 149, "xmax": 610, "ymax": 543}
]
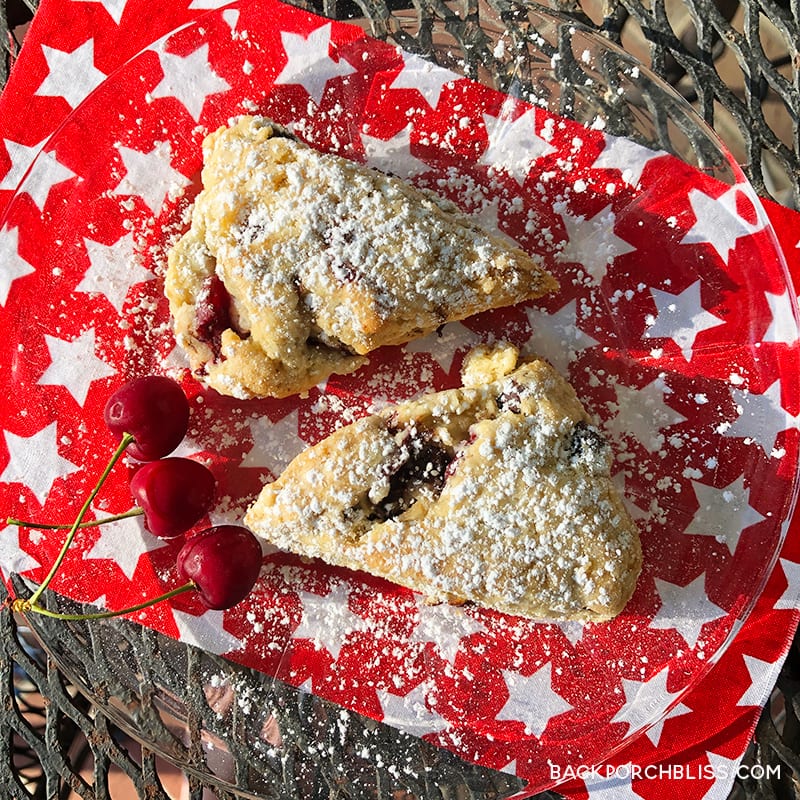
[{"xmin": 131, "ymin": 457, "xmax": 216, "ymax": 539}]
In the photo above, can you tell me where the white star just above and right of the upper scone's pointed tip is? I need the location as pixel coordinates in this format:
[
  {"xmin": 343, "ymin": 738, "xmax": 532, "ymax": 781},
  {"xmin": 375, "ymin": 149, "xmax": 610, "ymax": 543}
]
[{"xmin": 558, "ymin": 205, "xmax": 636, "ymax": 285}]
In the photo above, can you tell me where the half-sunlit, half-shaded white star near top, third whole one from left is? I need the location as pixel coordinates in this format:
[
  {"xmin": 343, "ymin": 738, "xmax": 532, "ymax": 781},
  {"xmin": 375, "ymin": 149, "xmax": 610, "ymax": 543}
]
[{"xmin": 275, "ymin": 22, "xmax": 356, "ymax": 105}]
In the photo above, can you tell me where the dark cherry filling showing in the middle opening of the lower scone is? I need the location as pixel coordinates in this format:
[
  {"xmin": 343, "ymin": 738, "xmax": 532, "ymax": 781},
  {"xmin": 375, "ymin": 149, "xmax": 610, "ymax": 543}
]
[{"xmin": 370, "ymin": 428, "xmax": 454, "ymax": 521}]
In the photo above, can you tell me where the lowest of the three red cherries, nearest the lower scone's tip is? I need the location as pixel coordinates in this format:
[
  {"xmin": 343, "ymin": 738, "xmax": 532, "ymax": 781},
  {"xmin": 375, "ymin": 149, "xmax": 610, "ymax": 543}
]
[{"xmin": 178, "ymin": 525, "xmax": 262, "ymax": 609}]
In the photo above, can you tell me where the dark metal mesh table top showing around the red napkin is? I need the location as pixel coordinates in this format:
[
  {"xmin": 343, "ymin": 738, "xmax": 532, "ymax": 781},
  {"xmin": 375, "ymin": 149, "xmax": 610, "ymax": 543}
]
[{"xmin": 0, "ymin": 0, "xmax": 800, "ymax": 800}]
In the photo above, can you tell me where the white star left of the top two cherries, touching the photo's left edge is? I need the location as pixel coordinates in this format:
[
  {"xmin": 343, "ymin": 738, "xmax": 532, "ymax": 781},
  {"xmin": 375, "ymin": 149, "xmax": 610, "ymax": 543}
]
[{"xmin": 0, "ymin": 422, "xmax": 80, "ymax": 505}]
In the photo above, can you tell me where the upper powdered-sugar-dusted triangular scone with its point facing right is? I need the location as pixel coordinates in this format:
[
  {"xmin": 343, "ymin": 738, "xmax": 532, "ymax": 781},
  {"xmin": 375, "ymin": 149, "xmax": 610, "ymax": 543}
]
[{"xmin": 166, "ymin": 117, "xmax": 557, "ymax": 397}]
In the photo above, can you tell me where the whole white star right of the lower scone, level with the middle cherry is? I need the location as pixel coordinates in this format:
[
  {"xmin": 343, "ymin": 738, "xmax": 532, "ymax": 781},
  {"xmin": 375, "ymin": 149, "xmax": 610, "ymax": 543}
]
[{"xmin": 684, "ymin": 475, "xmax": 766, "ymax": 555}]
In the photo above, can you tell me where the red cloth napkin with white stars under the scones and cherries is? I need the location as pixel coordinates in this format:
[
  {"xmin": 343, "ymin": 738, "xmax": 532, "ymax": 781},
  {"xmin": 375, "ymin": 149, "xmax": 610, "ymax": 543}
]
[{"xmin": 0, "ymin": 0, "xmax": 800, "ymax": 798}]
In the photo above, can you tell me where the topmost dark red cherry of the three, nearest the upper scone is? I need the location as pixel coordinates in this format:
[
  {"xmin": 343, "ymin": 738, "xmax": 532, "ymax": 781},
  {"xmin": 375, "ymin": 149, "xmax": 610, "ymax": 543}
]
[{"xmin": 104, "ymin": 375, "xmax": 189, "ymax": 461}]
